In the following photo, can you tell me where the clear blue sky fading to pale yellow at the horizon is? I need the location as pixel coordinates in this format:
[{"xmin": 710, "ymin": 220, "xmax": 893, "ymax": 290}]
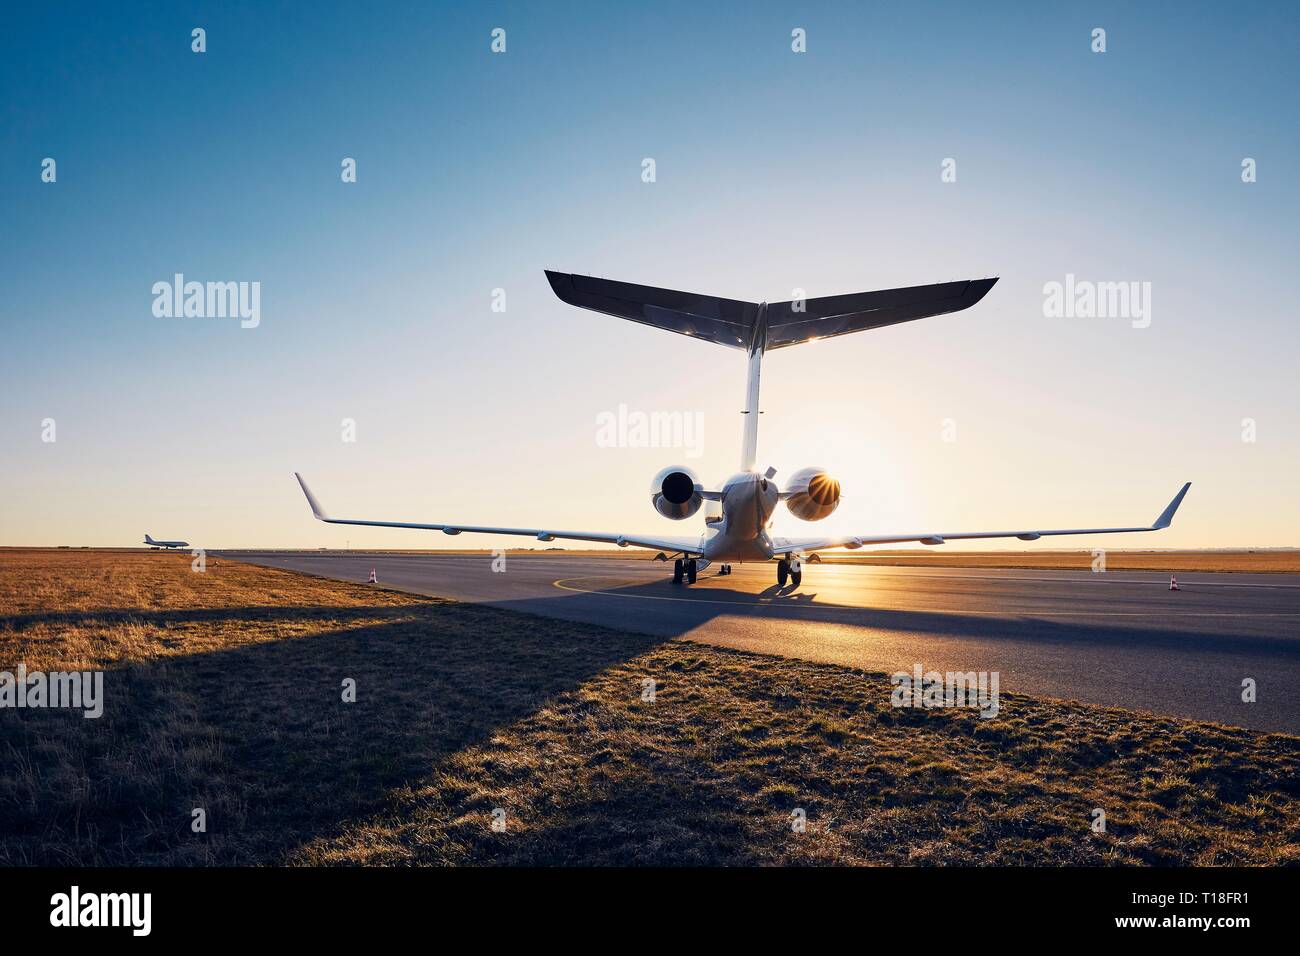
[{"xmin": 0, "ymin": 3, "xmax": 1300, "ymax": 548}]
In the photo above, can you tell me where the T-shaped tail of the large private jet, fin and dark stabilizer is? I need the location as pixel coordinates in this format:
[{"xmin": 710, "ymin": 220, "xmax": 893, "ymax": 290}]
[{"xmin": 546, "ymin": 271, "xmax": 997, "ymax": 471}]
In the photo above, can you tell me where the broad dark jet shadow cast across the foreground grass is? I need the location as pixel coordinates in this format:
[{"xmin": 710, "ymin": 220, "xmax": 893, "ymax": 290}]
[{"xmin": 0, "ymin": 604, "xmax": 662, "ymax": 865}]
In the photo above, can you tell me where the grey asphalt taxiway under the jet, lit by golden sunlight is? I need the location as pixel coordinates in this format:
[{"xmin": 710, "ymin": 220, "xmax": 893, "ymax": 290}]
[{"xmin": 218, "ymin": 551, "xmax": 1300, "ymax": 734}]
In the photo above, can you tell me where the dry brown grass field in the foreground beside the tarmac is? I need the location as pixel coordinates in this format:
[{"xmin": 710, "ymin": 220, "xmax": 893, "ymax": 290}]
[{"xmin": 0, "ymin": 550, "xmax": 1300, "ymax": 865}]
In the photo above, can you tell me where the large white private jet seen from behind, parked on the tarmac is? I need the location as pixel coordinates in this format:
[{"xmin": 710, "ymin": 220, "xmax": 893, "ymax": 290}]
[{"xmin": 295, "ymin": 272, "xmax": 1191, "ymax": 588}]
